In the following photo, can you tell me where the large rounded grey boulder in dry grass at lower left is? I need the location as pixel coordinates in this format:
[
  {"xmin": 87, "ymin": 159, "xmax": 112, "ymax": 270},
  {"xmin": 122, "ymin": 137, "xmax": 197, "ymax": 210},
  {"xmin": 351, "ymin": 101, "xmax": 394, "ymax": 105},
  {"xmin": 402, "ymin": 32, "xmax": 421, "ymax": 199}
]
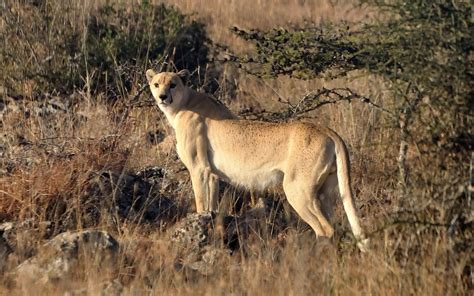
[{"xmin": 16, "ymin": 230, "xmax": 118, "ymax": 283}]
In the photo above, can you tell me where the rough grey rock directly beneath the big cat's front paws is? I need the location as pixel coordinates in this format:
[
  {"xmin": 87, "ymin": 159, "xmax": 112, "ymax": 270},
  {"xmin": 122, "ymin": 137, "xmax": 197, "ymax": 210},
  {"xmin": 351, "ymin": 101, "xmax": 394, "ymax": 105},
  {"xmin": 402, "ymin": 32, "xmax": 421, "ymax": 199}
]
[{"xmin": 171, "ymin": 198, "xmax": 287, "ymax": 275}]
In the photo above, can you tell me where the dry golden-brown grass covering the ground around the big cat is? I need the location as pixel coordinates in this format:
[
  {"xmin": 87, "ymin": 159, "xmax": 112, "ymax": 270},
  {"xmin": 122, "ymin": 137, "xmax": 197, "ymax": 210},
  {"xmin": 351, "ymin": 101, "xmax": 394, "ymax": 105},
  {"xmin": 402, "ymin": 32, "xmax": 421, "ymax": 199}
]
[{"xmin": 0, "ymin": 0, "xmax": 470, "ymax": 295}]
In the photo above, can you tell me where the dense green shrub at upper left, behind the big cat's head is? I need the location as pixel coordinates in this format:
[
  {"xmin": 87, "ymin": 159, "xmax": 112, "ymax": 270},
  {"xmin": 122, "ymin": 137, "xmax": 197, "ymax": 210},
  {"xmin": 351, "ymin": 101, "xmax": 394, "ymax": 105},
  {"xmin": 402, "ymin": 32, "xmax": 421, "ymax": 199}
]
[{"xmin": 0, "ymin": 0, "xmax": 208, "ymax": 98}]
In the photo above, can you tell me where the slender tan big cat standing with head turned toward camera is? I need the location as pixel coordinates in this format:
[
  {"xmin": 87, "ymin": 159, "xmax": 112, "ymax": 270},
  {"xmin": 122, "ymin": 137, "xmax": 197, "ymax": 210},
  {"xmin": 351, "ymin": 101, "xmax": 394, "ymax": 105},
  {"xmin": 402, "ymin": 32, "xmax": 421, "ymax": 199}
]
[{"xmin": 147, "ymin": 70, "xmax": 368, "ymax": 251}]
